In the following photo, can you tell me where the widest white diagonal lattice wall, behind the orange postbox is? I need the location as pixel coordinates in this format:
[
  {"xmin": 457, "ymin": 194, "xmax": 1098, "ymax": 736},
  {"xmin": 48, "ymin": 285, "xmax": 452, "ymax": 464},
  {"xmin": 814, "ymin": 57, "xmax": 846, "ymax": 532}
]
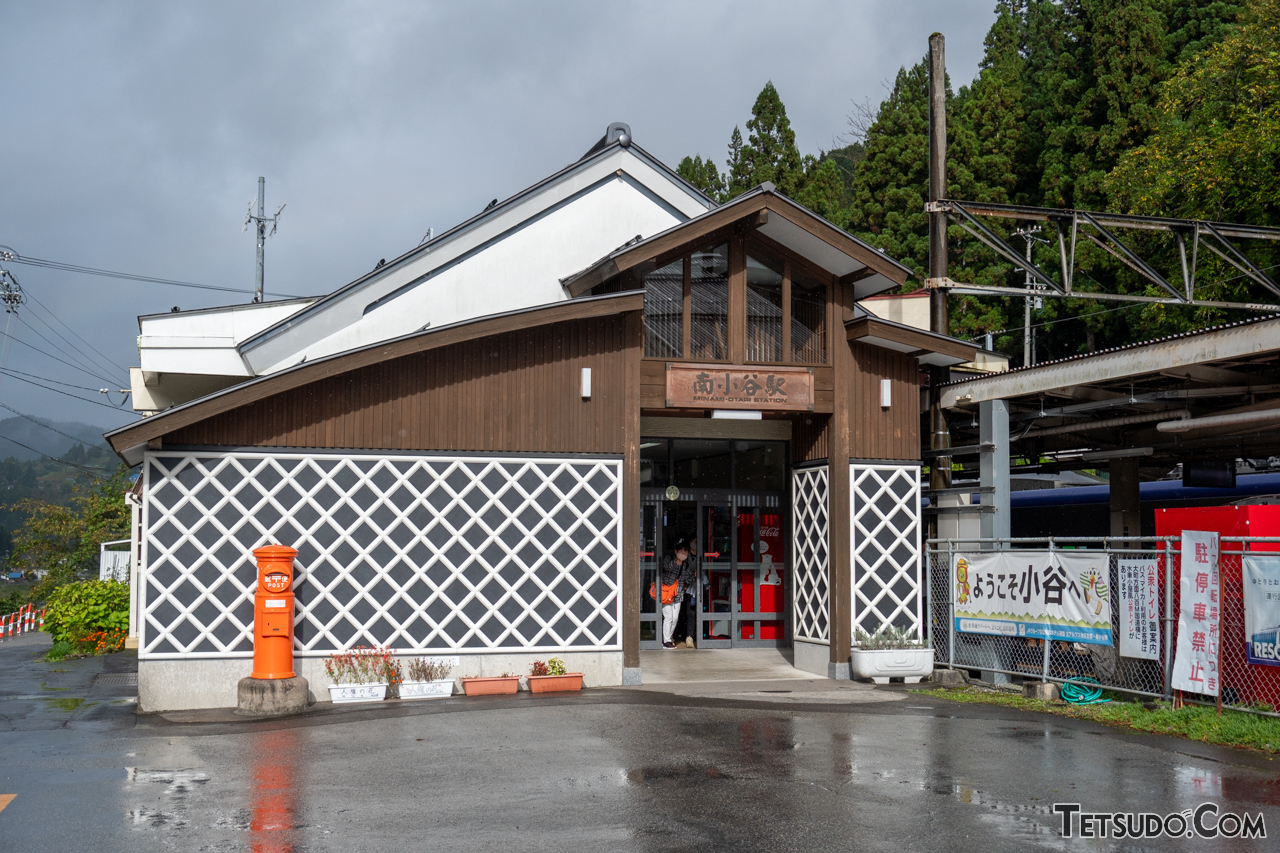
[{"xmin": 140, "ymin": 451, "xmax": 622, "ymax": 658}]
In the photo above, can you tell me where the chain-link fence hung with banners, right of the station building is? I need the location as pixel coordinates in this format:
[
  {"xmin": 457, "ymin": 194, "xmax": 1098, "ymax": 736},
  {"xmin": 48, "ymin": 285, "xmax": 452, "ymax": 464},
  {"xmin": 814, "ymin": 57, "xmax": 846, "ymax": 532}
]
[{"xmin": 928, "ymin": 537, "xmax": 1280, "ymax": 716}]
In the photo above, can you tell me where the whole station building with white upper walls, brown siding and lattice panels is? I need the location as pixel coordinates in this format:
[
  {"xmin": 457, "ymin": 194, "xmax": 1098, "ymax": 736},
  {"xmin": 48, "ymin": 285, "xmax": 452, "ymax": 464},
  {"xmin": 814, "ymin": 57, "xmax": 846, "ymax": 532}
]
[{"xmin": 108, "ymin": 124, "xmax": 975, "ymax": 711}]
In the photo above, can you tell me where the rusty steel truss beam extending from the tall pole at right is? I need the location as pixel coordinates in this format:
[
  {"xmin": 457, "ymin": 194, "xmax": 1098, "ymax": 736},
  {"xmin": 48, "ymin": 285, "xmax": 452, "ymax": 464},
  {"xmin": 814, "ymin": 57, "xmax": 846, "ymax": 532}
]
[{"xmin": 925, "ymin": 200, "xmax": 1280, "ymax": 313}]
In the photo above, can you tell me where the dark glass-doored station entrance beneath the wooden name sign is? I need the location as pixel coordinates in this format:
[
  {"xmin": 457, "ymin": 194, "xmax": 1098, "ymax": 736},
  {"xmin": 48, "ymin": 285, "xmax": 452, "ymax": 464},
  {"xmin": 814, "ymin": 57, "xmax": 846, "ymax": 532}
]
[{"xmin": 640, "ymin": 438, "xmax": 791, "ymax": 649}]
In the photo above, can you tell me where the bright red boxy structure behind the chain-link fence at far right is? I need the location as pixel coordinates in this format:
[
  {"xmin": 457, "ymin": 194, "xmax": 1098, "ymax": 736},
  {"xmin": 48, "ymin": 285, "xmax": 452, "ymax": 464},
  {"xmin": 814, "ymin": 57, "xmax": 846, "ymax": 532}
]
[{"xmin": 1156, "ymin": 506, "xmax": 1280, "ymax": 708}]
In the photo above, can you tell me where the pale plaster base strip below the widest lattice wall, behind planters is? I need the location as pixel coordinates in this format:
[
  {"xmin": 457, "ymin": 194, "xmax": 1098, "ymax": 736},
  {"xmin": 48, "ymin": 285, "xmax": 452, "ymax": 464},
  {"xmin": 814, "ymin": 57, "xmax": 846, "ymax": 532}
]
[{"xmin": 138, "ymin": 652, "xmax": 622, "ymax": 713}]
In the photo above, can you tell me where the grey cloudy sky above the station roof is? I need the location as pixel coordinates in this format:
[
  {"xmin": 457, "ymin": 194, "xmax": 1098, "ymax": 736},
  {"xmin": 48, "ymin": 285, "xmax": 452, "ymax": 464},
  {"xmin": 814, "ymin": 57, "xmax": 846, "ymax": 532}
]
[{"xmin": 0, "ymin": 0, "xmax": 995, "ymax": 435}]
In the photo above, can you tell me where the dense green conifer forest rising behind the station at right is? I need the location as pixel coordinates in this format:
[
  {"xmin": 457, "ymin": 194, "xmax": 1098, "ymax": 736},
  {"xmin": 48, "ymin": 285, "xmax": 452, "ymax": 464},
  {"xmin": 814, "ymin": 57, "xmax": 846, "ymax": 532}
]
[{"xmin": 680, "ymin": 0, "xmax": 1280, "ymax": 362}]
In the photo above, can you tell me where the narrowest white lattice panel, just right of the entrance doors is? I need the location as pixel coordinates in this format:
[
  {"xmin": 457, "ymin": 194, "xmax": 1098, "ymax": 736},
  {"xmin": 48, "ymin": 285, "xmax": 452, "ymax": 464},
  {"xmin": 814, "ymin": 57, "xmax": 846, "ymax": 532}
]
[{"xmin": 791, "ymin": 465, "xmax": 831, "ymax": 643}]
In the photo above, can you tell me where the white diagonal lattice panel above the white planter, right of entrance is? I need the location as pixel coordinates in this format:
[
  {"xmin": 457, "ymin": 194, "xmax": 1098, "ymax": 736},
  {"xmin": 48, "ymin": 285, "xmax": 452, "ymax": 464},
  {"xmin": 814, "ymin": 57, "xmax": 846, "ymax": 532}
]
[{"xmin": 849, "ymin": 465, "xmax": 924, "ymax": 642}]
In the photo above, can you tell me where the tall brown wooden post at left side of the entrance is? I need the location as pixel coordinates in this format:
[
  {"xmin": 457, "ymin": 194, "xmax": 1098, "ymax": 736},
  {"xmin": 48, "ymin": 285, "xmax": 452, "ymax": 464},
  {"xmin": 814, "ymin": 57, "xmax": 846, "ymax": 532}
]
[{"xmin": 622, "ymin": 311, "xmax": 644, "ymax": 684}]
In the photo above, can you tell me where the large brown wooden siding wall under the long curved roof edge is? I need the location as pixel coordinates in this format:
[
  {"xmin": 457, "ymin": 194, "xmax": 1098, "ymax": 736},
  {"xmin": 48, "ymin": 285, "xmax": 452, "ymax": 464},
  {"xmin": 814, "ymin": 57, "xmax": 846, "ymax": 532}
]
[{"xmin": 164, "ymin": 316, "xmax": 639, "ymax": 453}]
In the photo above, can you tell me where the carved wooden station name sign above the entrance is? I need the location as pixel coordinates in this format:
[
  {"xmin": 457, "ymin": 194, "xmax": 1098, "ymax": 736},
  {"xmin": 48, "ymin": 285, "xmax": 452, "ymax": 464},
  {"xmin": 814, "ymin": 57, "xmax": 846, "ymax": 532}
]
[{"xmin": 667, "ymin": 364, "xmax": 813, "ymax": 411}]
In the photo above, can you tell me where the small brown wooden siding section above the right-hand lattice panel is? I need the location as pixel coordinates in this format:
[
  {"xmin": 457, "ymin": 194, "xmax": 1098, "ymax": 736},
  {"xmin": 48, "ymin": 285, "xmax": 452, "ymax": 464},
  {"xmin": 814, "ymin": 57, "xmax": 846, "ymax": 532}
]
[{"xmin": 849, "ymin": 343, "xmax": 920, "ymax": 460}]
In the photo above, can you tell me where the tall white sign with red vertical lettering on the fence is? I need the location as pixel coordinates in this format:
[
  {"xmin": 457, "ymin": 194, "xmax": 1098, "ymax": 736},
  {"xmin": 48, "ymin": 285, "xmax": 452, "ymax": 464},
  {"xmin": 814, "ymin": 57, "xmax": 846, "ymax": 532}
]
[{"xmin": 1174, "ymin": 530, "xmax": 1222, "ymax": 695}]
